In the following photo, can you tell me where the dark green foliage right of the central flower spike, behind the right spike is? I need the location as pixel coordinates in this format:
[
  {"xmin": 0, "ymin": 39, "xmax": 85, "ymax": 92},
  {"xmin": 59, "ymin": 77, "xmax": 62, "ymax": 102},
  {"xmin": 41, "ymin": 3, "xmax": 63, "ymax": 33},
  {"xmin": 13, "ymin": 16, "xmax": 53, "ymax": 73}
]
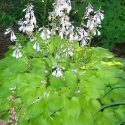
[{"xmin": 72, "ymin": 0, "xmax": 125, "ymax": 51}]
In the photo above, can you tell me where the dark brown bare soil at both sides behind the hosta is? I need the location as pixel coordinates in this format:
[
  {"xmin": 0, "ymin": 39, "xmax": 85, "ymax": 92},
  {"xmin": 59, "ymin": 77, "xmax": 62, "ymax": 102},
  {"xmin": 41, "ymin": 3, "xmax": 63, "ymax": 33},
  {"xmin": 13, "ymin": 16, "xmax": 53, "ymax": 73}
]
[{"xmin": 0, "ymin": 27, "xmax": 125, "ymax": 59}]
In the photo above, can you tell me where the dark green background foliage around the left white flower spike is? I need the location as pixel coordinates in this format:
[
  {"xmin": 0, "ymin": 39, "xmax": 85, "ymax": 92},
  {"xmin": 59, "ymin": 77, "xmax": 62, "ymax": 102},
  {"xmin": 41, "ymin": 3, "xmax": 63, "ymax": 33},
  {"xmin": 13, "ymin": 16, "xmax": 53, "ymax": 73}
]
[{"xmin": 0, "ymin": 0, "xmax": 53, "ymax": 28}]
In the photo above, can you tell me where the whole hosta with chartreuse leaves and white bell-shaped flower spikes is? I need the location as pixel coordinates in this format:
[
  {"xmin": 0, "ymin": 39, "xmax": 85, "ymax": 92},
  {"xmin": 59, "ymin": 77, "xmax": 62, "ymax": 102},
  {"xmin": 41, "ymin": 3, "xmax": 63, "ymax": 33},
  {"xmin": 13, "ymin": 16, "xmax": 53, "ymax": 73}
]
[{"xmin": 0, "ymin": 0, "xmax": 125, "ymax": 125}]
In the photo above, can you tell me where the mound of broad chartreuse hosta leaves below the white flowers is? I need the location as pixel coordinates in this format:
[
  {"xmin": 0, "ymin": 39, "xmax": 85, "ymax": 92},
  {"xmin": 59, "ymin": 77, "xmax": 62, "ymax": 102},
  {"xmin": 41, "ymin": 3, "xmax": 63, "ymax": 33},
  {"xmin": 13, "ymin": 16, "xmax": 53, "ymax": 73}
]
[{"xmin": 0, "ymin": 42, "xmax": 125, "ymax": 125}]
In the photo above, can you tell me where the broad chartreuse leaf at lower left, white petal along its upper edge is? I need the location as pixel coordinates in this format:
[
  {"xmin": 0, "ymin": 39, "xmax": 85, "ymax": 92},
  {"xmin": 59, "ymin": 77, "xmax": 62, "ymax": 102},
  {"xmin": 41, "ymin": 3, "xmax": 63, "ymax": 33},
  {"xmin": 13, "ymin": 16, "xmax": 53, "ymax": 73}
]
[{"xmin": 27, "ymin": 98, "xmax": 44, "ymax": 118}]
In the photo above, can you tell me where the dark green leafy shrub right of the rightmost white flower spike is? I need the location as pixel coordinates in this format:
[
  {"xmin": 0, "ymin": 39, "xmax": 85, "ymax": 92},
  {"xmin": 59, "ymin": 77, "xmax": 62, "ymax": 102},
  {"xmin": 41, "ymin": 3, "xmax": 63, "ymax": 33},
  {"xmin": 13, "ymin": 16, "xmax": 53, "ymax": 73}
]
[{"xmin": 94, "ymin": 0, "xmax": 125, "ymax": 49}]
